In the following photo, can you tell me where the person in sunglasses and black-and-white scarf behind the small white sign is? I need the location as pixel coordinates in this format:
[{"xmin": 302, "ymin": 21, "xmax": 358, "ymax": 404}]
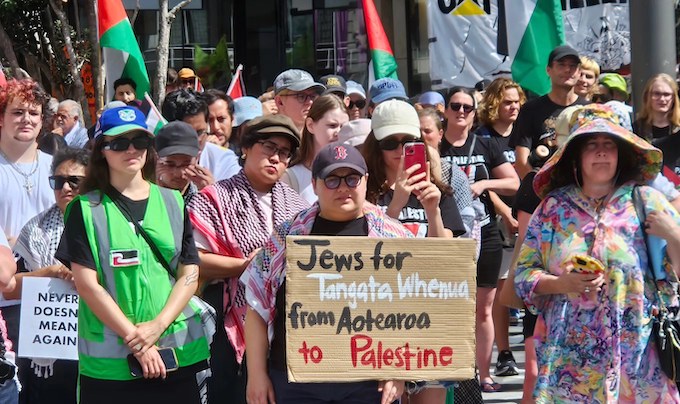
[{"xmin": 10, "ymin": 148, "xmax": 90, "ymax": 404}]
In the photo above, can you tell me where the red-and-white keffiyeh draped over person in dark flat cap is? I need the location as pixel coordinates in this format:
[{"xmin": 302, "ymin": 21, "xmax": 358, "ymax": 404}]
[{"xmin": 188, "ymin": 170, "xmax": 308, "ymax": 363}]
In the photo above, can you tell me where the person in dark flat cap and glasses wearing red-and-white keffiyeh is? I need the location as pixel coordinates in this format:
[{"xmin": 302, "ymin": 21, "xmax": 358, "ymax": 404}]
[{"xmin": 188, "ymin": 115, "xmax": 309, "ymax": 404}]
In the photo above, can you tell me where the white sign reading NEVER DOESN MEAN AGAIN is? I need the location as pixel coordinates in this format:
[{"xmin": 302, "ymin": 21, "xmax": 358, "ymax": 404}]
[{"xmin": 18, "ymin": 276, "xmax": 78, "ymax": 360}]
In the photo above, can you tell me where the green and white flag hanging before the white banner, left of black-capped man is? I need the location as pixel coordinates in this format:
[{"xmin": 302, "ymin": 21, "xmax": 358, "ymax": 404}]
[{"xmin": 505, "ymin": 0, "xmax": 565, "ymax": 95}]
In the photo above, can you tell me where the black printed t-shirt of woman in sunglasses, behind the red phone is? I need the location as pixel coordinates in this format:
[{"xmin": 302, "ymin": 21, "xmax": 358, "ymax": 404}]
[{"xmin": 439, "ymin": 134, "xmax": 508, "ymax": 222}]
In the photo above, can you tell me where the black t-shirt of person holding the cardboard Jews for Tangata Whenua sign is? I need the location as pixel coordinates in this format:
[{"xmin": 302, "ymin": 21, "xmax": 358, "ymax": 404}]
[{"xmin": 269, "ymin": 215, "xmax": 368, "ymax": 371}]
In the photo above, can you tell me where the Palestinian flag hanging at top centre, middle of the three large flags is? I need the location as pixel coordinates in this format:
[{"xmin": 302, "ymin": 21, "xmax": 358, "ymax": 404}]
[{"xmin": 362, "ymin": 0, "xmax": 397, "ymax": 81}]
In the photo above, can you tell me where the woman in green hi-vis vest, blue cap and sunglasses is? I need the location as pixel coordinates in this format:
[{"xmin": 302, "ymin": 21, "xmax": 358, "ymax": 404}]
[{"xmin": 56, "ymin": 106, "xmax": 211, "ymax": 404}]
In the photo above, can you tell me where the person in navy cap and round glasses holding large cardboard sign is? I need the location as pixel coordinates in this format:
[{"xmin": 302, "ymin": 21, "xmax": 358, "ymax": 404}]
[{"xmin": 241, "ymin": 143, "xmax": 412, "ymax": 404}]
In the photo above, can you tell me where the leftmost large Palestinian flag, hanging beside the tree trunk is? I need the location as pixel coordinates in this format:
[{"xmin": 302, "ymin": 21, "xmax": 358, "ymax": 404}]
[{"xmin": 97, "ymin": 0, "xmax": 150, "ymax": 100}]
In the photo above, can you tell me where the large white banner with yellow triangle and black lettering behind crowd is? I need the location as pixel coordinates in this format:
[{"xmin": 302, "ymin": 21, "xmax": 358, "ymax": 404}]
[{"xmin": 427, "ymin": 0, "xmax": 631, "ymax": 89}]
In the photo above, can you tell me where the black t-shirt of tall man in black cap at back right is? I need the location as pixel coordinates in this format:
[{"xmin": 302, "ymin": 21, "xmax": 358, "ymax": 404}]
[{"xmin": 510, "ymin": 94, "xmax": 589, "ymax": 150}]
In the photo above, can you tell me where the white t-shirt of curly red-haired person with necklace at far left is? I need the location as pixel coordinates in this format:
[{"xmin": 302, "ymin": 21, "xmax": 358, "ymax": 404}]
[{"xmin": 0, "ymin": 151, "xmax": 55, "ymax": 237}]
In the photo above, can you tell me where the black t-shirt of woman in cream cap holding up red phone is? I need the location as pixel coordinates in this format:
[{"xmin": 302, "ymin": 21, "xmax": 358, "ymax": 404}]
[{"xmin": 377, "ymin": 189, "xmax": 465, "ymax": 237}]
